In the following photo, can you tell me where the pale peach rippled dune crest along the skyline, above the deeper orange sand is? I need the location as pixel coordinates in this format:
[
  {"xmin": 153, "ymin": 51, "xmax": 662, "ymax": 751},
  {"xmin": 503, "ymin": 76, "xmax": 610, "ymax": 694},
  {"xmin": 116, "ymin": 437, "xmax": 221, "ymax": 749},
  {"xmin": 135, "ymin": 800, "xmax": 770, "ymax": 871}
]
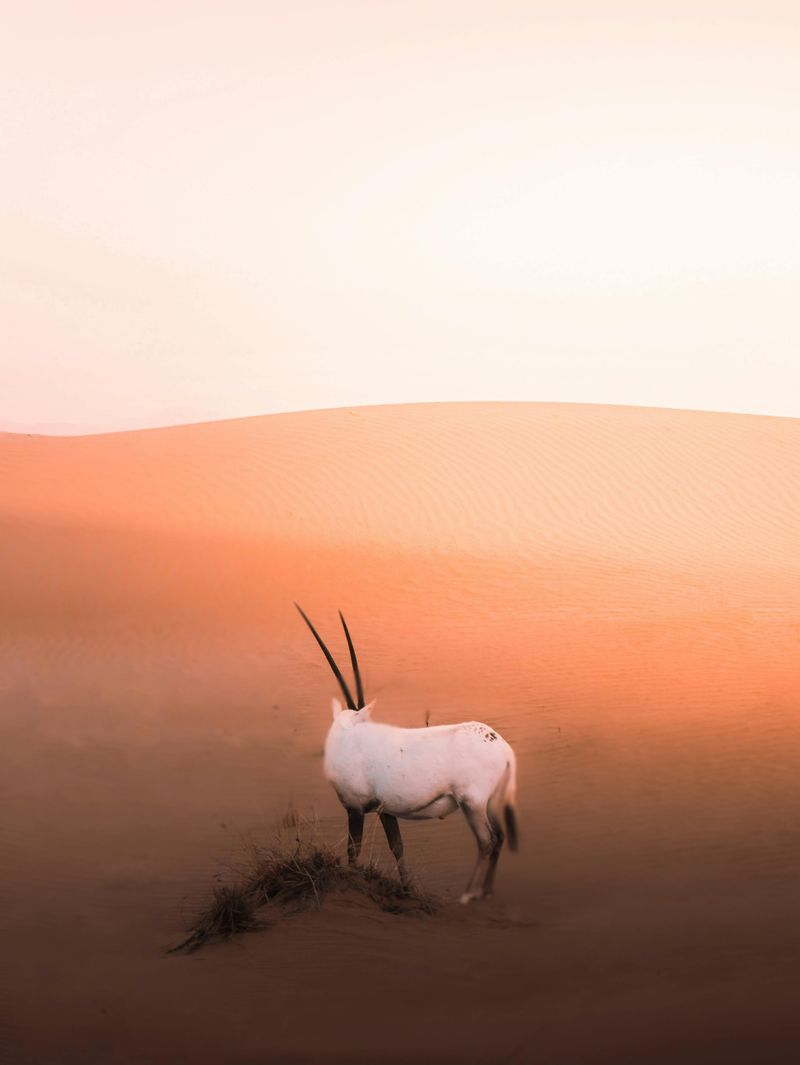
[{"xmin": 0, "ymin": 404, "xmax": 800, "ymax": 566}]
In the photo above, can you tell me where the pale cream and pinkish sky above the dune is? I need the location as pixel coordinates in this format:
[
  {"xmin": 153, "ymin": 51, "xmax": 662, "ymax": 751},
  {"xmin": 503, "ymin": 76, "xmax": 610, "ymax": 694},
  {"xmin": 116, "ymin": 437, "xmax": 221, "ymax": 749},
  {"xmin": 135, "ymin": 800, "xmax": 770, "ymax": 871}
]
[{"xmin": 0, "ymin": 0, "xmax": 800, "ymax": 432}]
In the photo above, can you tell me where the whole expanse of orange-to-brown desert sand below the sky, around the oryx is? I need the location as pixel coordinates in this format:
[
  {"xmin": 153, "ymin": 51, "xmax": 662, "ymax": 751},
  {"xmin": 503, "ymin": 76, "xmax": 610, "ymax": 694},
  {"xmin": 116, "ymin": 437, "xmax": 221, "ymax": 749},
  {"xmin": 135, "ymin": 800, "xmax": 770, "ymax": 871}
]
[{"xmin": 0, "ymin": 404, "xmax": 800, "ymax": 1065}]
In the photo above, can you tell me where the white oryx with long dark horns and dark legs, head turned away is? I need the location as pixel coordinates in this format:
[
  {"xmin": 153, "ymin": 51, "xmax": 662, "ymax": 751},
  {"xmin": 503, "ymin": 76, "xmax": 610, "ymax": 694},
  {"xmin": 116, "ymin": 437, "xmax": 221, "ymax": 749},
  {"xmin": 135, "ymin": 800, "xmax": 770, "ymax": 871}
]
[{"xmin": 295, "ymin": 603, "xmax": 517, "ymax": 902}]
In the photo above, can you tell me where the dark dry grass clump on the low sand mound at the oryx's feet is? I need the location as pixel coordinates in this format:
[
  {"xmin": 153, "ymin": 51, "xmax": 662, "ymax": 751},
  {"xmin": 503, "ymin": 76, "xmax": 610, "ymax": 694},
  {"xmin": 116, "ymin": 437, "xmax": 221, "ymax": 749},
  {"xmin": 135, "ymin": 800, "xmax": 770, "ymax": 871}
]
[{"xmin": 168, "ymin": 817, "xmax": 438, "ymax": 953}]
